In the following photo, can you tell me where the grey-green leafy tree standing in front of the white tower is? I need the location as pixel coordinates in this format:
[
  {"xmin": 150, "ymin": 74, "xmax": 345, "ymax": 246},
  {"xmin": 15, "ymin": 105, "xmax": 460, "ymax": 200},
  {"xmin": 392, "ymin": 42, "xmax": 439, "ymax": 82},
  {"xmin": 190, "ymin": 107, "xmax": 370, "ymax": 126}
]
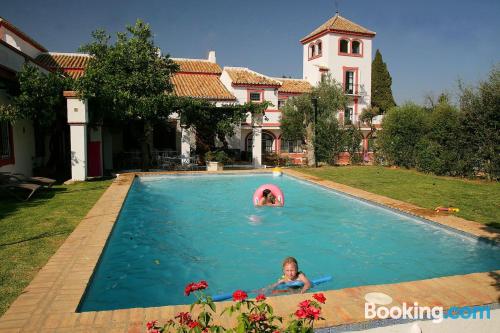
[{"xmin": 281, "ymin": 76, "xmax": 347, "ymax": 166}]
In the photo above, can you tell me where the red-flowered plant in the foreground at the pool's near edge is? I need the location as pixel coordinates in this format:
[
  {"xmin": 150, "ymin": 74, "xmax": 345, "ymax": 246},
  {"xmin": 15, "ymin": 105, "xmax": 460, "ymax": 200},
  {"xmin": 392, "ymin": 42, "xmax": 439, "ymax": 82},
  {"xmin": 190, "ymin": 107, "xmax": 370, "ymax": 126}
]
[{"xmin": 146, "ymin": 281, "xmax": 326, "ymax": 333}]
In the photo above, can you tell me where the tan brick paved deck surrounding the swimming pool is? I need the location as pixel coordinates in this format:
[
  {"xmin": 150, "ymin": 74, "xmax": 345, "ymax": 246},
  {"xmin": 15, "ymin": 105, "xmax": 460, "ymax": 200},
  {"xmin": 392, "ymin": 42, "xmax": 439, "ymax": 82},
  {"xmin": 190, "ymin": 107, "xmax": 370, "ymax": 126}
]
[{"xmin": 0, "ymin": 169, "xmax": 500, "ymax": 333}]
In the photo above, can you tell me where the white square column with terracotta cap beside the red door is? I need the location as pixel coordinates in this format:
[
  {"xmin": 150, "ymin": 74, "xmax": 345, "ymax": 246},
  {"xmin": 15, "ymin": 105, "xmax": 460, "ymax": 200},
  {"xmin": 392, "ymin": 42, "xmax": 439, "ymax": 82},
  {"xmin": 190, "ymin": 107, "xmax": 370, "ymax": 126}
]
[{"xmin": 64, "ymin": 91, "xmax": 89, "ymax": 181}]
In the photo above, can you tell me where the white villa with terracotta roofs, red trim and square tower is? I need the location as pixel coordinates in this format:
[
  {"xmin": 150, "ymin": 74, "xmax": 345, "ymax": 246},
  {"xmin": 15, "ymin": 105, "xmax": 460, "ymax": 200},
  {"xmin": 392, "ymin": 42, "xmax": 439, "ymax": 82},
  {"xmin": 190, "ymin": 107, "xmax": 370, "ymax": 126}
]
[{"xmin": 0, "ymin": 14, "xmax": 382, "ymax": 180}]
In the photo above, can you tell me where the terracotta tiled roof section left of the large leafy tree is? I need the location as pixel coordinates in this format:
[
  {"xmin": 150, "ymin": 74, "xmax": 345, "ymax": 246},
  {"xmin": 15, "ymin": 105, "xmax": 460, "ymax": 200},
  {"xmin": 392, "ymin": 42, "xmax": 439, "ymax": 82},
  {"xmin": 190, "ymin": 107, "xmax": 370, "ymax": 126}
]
[{"xmin": 36, "ymin": 52, "xmax": 90, "ymax": 79}]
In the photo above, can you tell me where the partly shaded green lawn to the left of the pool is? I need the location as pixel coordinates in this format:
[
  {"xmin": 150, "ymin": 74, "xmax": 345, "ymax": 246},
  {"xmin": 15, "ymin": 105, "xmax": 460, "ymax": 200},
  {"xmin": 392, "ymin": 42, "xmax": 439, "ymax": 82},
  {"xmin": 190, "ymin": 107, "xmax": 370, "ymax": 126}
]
[{"xmin": 0, "ymin": 180, "xmax": 111, "ymax": 316}]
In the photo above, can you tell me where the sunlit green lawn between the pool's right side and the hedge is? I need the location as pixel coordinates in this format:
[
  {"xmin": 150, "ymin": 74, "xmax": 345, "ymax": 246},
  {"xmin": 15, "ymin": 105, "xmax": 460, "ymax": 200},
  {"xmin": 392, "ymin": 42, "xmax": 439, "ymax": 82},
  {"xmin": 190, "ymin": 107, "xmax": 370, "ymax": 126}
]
[{"xmin": 296, "ymin": 166, "xmax": 500, "ymax": 228}]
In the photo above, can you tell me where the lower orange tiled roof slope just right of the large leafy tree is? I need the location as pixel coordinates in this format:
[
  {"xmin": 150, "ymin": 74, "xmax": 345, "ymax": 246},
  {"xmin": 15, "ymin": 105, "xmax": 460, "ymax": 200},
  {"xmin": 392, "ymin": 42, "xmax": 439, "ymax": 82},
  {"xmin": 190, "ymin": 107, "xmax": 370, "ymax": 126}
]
[{"xmin": 172, "ymin": 73, "xmax": 236, "ymax": 101}]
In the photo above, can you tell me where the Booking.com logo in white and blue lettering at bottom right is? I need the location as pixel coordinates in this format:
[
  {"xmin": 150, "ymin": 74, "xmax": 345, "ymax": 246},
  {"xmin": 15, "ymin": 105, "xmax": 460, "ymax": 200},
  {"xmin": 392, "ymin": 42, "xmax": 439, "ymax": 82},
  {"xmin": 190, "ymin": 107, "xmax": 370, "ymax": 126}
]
[{"xmin": 365, "ymin": 293, "xmax": 490, "ymax": 323}]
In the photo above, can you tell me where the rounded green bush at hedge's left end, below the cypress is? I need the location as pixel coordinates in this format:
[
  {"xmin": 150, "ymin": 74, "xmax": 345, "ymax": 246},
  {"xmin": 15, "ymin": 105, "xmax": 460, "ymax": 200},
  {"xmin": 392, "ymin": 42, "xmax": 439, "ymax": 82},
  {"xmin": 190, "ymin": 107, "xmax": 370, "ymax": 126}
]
[{"xmin": 377, "ymin": 103, "xmax": 428, "ymax": 168}]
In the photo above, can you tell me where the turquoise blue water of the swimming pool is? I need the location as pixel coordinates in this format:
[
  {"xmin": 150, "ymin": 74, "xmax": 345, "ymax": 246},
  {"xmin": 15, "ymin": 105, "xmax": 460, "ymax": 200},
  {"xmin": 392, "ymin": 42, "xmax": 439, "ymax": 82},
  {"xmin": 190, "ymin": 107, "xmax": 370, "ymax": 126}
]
[{"xmin": 80, "ymin": 174, "xmax": 500, "ymax": 311}]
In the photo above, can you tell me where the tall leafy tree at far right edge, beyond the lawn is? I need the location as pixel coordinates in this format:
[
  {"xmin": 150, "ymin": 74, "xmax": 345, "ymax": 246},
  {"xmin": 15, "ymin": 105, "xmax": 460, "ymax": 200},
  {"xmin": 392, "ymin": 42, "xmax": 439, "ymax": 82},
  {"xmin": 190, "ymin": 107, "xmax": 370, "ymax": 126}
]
[{"xmin": 457, "ymin": 65, "xmax": 500, "ymax": 179}]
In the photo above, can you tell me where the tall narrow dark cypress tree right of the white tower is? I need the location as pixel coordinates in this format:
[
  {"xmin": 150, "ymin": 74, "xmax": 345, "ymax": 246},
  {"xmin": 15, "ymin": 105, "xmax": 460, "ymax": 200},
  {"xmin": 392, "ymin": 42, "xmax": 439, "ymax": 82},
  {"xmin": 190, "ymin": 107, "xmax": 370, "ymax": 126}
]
[{"xmin": 371, "ymin": 50, "xmax": 396, "ymax": 113}]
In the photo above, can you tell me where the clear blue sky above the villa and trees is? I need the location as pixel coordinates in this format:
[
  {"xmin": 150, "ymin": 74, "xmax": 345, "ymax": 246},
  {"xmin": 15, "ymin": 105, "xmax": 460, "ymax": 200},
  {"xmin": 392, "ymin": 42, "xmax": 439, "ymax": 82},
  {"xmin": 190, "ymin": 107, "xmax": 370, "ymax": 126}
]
[{"xmin": 0, "ymin": 0, "xmax": 500, "ymax": 104}]
